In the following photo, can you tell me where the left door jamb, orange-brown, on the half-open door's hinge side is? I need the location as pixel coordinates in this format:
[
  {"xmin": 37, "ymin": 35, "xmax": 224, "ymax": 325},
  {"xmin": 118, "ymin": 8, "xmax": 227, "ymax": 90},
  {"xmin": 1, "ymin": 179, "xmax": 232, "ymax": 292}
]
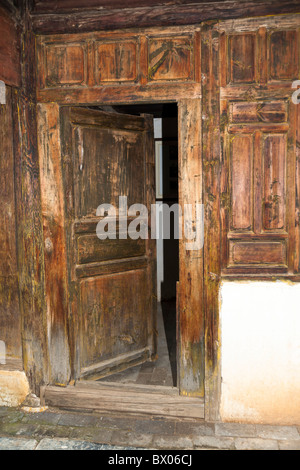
[{"xmin": 37, "ymin": 103, "xmax": 70, "ymax": 385}]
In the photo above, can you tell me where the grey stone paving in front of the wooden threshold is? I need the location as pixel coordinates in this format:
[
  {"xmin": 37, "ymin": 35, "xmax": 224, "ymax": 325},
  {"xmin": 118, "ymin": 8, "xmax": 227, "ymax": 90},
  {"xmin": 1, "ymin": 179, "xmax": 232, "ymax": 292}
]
[{"xmin": 0, "ymin": 408, "xmax": 300, "ymax": 450}]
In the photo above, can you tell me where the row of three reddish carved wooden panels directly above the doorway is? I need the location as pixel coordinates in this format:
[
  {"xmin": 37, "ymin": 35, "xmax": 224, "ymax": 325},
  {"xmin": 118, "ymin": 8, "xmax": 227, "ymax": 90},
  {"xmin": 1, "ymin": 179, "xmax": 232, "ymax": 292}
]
[{"xmin": 37, "ymin": 27, "xmax": 201, "ymax": 103}]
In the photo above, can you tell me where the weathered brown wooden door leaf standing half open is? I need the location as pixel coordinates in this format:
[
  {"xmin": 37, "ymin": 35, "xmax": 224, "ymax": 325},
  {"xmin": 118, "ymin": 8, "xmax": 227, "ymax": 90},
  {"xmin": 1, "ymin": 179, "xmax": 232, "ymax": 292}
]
[{"xmin": 61, "ymin": 107, "xmax": 157, "ymax": 380}]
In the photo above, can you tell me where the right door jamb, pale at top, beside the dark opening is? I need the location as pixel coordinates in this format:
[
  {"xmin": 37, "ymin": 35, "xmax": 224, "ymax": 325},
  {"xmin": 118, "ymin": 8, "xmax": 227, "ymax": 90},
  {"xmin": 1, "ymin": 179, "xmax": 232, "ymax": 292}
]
[{"xmin": 177, "ymin": 98, "xmax": 204, "ymax": 397}]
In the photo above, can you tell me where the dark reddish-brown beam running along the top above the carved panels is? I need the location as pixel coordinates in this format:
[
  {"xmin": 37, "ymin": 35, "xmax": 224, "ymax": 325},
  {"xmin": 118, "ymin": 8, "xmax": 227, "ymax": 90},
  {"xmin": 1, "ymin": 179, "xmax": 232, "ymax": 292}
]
[{"xmin": 32, "ymin": 0, "xmax": 300, "ymax": 34}]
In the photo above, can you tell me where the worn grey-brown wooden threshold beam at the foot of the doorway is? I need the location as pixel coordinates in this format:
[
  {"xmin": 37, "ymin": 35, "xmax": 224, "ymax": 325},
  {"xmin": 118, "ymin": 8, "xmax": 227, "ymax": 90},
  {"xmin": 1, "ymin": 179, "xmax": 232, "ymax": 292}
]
[{"xmin": 42, "ymin": 382, "xmax": 204, "ymax": 419}]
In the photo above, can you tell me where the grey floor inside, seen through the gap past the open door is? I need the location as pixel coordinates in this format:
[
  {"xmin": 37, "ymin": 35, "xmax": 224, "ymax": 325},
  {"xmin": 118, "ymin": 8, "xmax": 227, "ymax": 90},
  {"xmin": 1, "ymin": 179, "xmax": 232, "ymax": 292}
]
[{"xmin": 98, "ymin": 302, "xmax": 176, "ymax": 387}]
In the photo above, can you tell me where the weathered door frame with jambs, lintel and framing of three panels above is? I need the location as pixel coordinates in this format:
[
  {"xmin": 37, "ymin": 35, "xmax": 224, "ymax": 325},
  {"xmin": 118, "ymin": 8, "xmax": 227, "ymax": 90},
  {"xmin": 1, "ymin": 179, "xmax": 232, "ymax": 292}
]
[{"xmin": 38, "ymin": 27, "xmax": 211, "ymax": 414}]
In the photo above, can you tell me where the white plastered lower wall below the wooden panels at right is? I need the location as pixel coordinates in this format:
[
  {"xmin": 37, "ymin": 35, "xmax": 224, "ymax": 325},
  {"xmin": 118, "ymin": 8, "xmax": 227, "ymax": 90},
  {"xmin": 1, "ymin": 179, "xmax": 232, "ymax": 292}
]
[{"xmin": 220, "ymin": 281, "xmax": 300, "ymax": 425}]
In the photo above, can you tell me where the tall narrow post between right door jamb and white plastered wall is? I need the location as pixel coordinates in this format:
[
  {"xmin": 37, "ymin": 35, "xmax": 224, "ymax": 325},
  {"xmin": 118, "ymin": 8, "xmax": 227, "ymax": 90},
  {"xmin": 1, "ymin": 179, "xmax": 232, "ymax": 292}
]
[{"xmin": 201, "ymin": 24, "xmax": 222, "ymax": 421}]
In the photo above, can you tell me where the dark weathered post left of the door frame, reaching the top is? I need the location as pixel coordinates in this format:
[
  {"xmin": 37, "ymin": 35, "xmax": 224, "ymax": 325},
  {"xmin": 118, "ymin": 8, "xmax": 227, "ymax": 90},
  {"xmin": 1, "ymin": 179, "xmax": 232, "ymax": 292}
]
[{"xmin": 13, "ymin": 2, "xmax": 48, "ymax": 393}]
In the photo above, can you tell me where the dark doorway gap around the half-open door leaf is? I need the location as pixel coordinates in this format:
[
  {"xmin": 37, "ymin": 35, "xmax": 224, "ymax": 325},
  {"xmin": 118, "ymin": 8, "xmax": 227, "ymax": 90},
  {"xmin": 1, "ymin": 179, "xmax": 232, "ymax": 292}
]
[{"xmin": 94, "ymin": 103, "xmax": 179, "ymax": 387}]
